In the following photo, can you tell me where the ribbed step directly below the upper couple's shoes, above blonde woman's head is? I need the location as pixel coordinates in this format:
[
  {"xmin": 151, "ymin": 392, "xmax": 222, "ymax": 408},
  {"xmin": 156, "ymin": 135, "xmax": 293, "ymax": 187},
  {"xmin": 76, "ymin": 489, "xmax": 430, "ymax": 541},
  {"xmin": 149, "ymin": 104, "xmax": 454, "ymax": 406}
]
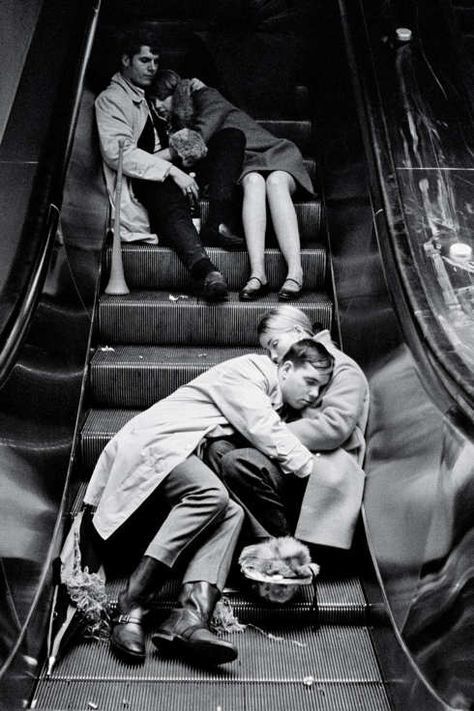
[{"xmin": 98, "ymin": 291, "xmax": 332, "ymax": 346}]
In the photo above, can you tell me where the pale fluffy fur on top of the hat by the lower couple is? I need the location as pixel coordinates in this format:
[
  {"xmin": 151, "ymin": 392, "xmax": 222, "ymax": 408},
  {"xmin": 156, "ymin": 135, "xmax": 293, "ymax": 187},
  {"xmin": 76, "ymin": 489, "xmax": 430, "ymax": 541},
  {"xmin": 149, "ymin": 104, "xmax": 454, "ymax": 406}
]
[{"xmin": 239, "ymin": 536, "xmax": 312, "ymax": 578}]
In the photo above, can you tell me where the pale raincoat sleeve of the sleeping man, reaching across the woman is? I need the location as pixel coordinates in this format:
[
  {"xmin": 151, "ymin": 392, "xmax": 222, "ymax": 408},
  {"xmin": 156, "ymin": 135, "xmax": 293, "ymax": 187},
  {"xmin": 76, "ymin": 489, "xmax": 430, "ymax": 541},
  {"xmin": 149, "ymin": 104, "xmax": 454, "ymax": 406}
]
[{"xmin": 207, "ymin": 368, "xmax": 313, "ymax": 477}]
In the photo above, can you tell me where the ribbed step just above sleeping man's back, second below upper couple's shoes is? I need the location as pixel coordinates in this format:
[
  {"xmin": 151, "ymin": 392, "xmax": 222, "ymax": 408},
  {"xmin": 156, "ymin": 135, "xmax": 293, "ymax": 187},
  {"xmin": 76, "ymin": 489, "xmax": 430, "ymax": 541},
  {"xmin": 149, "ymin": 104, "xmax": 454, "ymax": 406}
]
[{"xmin": 89, "ymin": 345, "xmax": 255, "ymax": 409}]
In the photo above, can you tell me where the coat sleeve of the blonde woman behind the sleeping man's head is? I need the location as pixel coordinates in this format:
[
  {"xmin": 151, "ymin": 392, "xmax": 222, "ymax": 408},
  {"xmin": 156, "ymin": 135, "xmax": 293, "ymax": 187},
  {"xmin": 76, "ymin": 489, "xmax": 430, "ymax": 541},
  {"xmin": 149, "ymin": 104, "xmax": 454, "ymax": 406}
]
[{"xmin": 288, "ymin": 367, "xmax": 367, "ymax": 452}]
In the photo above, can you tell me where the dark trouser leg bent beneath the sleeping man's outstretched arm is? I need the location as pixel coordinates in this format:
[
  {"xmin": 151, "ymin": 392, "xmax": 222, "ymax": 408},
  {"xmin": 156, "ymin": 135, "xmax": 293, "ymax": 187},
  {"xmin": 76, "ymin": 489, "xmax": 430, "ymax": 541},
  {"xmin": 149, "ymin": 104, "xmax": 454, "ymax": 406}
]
[{"xmin": 220, "ymin": 448, "xmax": 306, "ymax": 538}]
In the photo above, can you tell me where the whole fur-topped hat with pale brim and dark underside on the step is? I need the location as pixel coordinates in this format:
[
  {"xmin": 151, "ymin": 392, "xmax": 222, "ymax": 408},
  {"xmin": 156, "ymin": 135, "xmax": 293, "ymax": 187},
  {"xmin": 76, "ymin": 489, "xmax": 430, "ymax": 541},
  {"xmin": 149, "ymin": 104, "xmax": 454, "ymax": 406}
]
[{"xmin": 239, "ymin": 536, "xmax": 319, "ymax": 604}]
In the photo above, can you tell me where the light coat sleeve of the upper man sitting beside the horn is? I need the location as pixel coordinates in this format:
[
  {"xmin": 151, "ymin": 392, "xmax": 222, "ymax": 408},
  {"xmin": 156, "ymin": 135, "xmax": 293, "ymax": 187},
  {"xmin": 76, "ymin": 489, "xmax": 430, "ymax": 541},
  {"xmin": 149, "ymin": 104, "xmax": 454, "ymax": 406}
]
[{"xmin": 95, "ymin": 92, "xmax": 171, "ymax": 182}]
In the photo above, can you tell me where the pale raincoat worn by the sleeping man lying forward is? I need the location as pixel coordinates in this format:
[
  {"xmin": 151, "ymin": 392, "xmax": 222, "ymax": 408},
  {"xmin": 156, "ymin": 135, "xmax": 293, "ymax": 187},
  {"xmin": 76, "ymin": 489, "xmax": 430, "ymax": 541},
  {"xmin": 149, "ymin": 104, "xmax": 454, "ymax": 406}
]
[{"xmin": 84, "ymin": 354, "xmax": 314, "ymax": 539}]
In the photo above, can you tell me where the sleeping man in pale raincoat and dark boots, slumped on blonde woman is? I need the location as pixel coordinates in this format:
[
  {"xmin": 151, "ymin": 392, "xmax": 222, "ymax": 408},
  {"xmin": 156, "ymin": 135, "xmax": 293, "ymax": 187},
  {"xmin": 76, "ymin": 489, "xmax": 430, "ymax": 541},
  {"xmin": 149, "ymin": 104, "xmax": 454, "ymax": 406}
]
[{"xmin": 84, "ymin": 339, "xmax": 334, "ymax": 664}]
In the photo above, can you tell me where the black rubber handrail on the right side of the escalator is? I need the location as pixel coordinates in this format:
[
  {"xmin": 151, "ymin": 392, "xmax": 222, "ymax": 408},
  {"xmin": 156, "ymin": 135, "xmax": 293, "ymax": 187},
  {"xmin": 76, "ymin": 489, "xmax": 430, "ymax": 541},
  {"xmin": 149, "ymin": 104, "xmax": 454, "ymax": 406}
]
[{"xmin": 339, "ymin": 0, "xmax": 474, "ymax": 422}]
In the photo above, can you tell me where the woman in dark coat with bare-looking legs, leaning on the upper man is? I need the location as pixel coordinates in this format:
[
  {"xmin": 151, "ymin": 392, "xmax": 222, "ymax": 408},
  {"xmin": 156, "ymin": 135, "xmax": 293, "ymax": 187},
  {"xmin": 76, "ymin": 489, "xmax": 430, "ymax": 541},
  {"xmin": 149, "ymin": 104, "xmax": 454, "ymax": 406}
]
[{"xmin": 150, "ymin": 70, "xmax": 313, "ymax": 301}]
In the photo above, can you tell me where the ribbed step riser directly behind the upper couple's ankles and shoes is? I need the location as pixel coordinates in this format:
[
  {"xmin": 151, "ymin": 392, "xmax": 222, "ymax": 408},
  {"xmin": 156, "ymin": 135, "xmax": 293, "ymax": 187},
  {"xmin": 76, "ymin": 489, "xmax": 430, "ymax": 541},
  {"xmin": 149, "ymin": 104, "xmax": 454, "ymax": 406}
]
[{"xmin": 113, "ymin": 243, "xmax": 326, "ymax": 291}]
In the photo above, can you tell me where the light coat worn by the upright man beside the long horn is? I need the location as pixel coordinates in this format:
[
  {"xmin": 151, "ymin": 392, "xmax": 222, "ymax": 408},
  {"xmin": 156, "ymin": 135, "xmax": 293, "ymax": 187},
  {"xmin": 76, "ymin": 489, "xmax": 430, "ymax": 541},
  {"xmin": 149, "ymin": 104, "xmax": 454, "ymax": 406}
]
[{"xmin": 95, "ymin": 72, "xmax": 171, "ymax": 244}]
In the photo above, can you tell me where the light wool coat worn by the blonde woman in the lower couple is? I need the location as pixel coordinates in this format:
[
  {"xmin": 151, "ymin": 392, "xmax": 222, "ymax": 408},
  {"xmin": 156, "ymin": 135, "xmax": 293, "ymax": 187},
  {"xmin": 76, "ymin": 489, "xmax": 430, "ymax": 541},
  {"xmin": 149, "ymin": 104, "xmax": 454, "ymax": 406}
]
[{"xmin": 288, "ymin": 331, "xmax": 369, "ymax": 548}]
